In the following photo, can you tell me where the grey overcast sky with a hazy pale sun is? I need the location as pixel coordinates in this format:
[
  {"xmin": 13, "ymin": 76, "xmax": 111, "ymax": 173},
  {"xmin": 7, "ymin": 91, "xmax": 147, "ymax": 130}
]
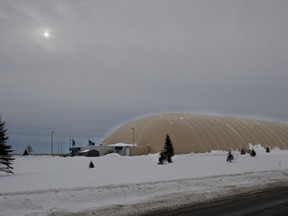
[{"xmin": 0, "ymin": 0, "xmax": 288, "ymax": 154}]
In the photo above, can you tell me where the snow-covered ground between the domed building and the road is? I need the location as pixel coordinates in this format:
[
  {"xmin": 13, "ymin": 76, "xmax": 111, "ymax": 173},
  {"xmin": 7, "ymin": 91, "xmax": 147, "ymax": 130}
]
[{"xmin": 0, "ymin": 147, "xmax": 288, "ymax": 216}]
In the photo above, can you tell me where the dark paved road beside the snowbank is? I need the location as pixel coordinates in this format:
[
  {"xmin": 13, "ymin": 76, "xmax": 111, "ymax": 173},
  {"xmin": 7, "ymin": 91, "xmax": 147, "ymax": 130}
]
[{"xmin": 150, "ymin": 187, "xmax": 288, "ymax": 216}]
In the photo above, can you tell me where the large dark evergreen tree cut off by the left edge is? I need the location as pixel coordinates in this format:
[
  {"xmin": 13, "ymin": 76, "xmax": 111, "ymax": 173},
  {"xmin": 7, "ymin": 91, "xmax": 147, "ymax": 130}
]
[{"xmin": 0, "ymin": 116, "xmax": 14, "ymax": 173}]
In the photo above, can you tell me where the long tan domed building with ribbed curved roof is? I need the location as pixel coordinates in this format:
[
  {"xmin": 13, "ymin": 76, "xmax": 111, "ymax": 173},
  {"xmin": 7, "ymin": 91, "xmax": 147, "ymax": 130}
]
[{"xmin": 102, "ymin": 113, "xmax": 288, "ymax": 155}]
